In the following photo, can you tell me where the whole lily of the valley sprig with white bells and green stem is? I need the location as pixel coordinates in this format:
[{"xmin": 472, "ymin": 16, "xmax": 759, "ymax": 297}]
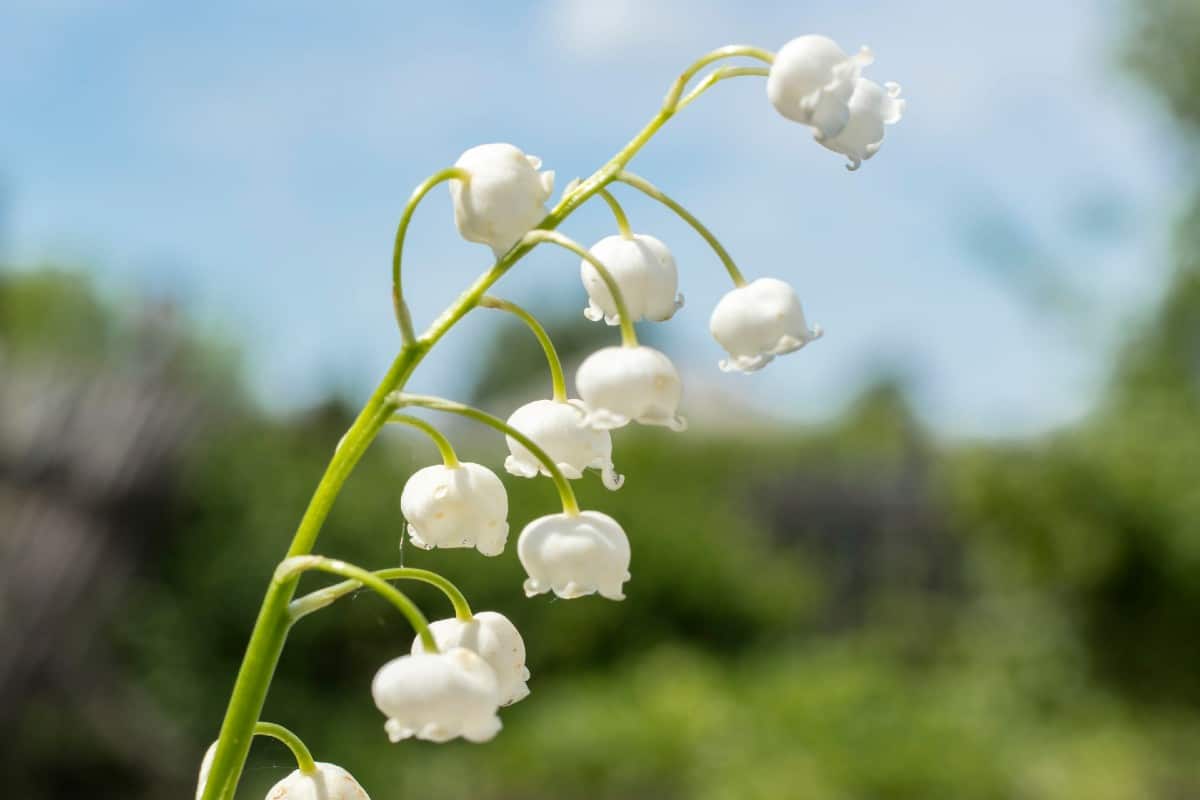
[{"xmin": 197, "ymin": 36, "xmax": 905, "ymax": 800}]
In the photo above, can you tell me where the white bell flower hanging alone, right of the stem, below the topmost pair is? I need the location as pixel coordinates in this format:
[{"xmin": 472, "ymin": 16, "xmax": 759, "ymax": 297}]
[{"xmin": 708, "ymin": 278, "xmax": 822, "ymax": 372}]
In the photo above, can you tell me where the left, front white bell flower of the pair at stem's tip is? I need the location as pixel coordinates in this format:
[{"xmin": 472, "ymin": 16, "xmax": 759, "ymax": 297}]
[{"xmin": 767, "ymin": 35, "xmax": 874, "ymax": 140}]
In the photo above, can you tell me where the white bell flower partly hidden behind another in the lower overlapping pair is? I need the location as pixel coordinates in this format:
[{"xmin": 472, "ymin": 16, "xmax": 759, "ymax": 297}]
[{"xmin": 413, "ymin": 612, "xmax": 529, "ymax": 705}]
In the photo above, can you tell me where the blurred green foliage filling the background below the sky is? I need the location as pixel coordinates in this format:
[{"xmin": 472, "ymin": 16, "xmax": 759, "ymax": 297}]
[{"xmin": 0, "ymin": 0, "xmax": 1200, "ymax": 800}]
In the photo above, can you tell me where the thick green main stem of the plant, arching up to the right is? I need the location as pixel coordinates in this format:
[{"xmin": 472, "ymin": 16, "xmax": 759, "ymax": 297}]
[{"xmin": 202, "ymin": 47, "xmax": 753, "ymax": 800}]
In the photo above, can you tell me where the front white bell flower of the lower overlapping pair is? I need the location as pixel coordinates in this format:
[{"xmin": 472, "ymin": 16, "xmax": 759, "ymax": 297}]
[{"xmin": 371, "ymin": 648, "xmax": 500, "ymax": 741}]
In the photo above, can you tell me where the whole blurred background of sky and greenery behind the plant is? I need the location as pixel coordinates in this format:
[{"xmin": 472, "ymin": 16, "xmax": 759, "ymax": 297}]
[{"xmin": 0, "ymin": 0, "xmax": 1200, "ymax": 800}]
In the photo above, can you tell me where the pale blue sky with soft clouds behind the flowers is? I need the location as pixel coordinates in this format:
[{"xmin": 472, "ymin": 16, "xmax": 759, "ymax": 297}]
[{"xmin": 0, "ymin": 0, "xmax": 1180, "ymax": 435}]
